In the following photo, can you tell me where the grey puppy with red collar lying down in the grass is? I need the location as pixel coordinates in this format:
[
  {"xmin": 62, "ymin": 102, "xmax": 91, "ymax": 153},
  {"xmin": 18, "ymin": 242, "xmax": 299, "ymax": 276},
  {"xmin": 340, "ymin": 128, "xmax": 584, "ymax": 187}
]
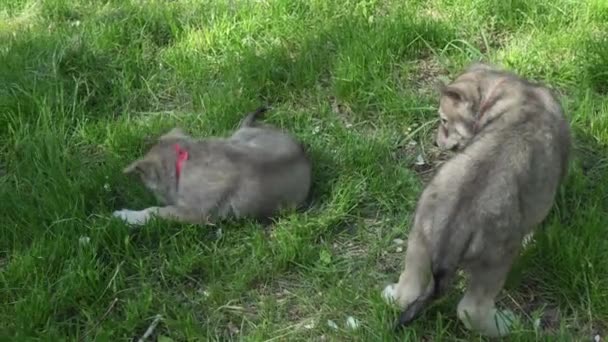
[{"xmin": 113, "ymin": 108, "xmax": 311, "ymax": 224}]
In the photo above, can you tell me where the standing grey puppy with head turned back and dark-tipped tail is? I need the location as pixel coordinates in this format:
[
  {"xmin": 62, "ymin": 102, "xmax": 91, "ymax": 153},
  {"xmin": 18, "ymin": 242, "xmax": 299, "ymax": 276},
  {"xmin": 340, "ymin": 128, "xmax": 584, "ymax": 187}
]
[{"xmin": 383, "ymin": 64, "xmax": 571, "ymax": 337}]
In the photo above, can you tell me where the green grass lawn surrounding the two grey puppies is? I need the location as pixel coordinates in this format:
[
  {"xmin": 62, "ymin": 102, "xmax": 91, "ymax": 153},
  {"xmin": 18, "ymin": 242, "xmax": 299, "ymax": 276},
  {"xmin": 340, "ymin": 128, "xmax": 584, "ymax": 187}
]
[{"xmin": 0, "ymin": 0, "xmax": 608, "ymax": 341}]
